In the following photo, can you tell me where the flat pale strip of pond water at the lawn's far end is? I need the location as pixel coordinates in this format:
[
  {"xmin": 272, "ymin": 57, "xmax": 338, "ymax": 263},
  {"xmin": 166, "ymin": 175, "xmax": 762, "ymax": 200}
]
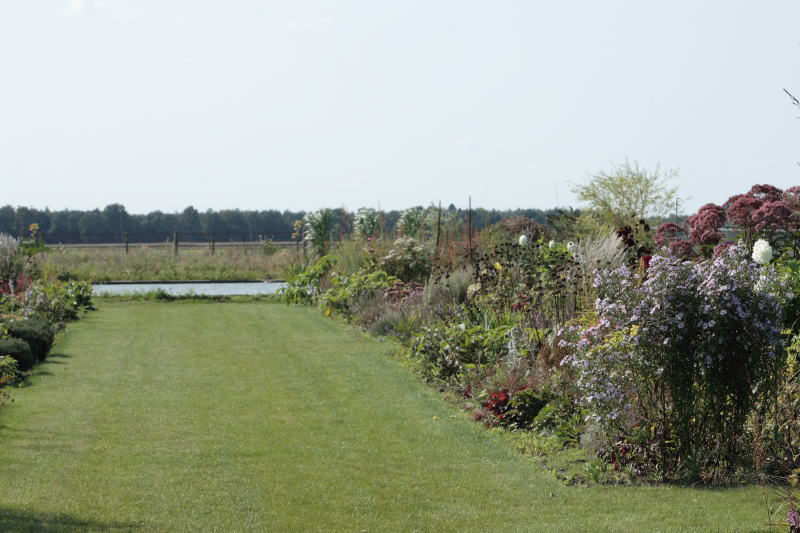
[{"xmin": 93, "ymin": 281, "xmax": 286, "ymax": 296}]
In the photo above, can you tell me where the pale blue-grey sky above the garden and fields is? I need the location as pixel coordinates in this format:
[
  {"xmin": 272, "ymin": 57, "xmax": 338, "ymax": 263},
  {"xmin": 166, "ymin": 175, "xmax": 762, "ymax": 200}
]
[{"xmin": 0, "ymin": 0, "xmax": 800, "ymax": 213}]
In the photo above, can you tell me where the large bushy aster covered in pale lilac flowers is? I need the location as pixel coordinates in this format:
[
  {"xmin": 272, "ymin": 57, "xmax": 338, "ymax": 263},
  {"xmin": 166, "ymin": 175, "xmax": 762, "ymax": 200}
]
[{"xmin": 562, "ymin": 247, "xmax": 783, "ymax": 474}]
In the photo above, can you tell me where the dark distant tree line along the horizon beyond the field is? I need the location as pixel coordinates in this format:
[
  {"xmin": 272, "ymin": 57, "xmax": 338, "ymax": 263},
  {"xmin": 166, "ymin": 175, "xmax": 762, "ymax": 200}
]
[{"xmin": 0, "ymin": 204, "xmax": 558, "ymax": 244}]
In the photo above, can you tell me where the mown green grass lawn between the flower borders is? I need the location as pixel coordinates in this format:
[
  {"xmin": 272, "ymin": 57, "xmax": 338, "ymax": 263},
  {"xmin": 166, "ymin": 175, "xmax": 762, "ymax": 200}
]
[{"xmin": 0, "ymin": 302, "xmax": 767, "ymax": 532}]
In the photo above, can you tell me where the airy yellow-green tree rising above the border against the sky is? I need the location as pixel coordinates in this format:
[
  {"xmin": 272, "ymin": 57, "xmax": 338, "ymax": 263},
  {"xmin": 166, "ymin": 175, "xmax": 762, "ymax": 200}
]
[{"xmin": 572, "ymin": 161, "xmax": 678, "ymax": 228}]
